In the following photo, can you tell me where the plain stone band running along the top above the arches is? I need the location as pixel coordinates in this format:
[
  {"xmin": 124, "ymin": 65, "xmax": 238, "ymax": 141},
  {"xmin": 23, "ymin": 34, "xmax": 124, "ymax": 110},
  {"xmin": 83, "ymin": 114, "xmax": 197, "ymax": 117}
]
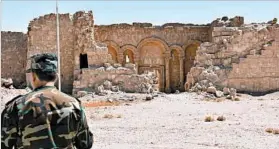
[{"xmin": 95, "ymin": 23, "xmax": 210, "ymax": 46}]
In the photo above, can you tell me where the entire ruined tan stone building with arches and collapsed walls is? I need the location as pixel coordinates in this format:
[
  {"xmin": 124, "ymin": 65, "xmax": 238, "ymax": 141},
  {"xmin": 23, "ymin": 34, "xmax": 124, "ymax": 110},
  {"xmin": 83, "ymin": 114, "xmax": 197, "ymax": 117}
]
[{"xmin": 1, "ymin": 12, "xmax": 279, "ymax": 93}]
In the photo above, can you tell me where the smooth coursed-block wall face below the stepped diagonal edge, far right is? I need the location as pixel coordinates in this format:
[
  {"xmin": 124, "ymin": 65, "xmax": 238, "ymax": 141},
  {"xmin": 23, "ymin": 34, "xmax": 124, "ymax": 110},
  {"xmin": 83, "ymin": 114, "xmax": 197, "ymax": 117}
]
[{"xmin": 228, "ymin": 27, "xmax": 279, "ymax": 94}]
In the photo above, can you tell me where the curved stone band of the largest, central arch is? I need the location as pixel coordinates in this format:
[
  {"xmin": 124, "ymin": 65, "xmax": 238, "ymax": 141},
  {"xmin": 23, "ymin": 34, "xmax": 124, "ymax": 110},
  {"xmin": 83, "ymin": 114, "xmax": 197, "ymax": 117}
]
[{"xmin": 137, "ymin": 37, "xmax": 170, "ymax": 53}]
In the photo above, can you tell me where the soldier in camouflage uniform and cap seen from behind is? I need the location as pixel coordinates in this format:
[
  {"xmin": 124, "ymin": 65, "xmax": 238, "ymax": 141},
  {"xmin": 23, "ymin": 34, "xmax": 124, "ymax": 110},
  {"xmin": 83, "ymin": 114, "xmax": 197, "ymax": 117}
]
[{"xmin": 1, "ymin": 54, "xmax": 93, "ymax": 149}]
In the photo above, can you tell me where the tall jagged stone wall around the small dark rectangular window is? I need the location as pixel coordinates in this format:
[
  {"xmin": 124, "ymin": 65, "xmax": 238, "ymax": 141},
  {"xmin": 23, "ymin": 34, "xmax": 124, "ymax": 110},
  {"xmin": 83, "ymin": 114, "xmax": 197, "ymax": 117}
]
[{"xmin": 73, "ymin": 11, "xmax": 111, "ymax": 69}]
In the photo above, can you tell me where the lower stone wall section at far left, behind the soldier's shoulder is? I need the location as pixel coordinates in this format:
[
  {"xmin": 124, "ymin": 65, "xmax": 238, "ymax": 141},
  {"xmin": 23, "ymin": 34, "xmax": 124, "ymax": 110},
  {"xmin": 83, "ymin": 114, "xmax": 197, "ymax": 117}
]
[{"xmin": 1, "ymin": 32, "xmax": 27, "ymax": 88}]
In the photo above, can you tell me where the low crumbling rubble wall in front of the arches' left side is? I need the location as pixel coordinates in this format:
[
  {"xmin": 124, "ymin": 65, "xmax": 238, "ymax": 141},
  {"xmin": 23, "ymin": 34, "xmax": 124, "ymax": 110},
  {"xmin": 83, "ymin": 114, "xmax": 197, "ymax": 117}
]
[{"xmin": 73, "ymin": 63, "xmax": 151, "ymax": 95}]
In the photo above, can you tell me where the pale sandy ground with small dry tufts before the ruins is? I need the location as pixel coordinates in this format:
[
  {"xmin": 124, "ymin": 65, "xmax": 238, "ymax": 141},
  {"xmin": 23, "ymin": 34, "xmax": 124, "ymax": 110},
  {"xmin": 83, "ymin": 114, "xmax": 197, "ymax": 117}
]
[{"xmin": 1, "ymin": 90, "xmax": 279, "ymax": 149}]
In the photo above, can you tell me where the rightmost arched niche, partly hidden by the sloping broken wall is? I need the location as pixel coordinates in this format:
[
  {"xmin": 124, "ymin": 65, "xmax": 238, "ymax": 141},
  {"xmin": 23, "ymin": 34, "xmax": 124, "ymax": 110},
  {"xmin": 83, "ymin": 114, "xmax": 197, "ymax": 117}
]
[{"xmin": 184, "ymin": 44, "xmax": 199, "ymax": 81}]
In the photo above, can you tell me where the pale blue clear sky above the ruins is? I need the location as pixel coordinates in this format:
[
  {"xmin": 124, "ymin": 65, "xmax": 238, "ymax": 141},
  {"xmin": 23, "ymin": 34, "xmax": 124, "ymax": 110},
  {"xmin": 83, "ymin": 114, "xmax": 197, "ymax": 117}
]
[{"xmin": 1, "ymin": 0, "xmax": 279, "ymax": 32}]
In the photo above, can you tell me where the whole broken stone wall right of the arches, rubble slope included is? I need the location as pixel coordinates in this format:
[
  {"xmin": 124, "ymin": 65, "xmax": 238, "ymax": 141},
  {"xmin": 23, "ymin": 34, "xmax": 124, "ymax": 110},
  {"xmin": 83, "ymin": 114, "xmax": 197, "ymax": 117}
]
[{"xmin": 185, "ymin": 25, "xmax": 279, "ymax": 92}]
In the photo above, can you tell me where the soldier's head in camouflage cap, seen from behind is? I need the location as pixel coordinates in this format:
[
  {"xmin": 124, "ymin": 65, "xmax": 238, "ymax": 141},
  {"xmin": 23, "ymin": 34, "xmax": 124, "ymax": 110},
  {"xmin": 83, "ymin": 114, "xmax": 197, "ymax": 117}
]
[{"xmin": 26, "ymin": 53, "xmax": 57, "ymax": 89}]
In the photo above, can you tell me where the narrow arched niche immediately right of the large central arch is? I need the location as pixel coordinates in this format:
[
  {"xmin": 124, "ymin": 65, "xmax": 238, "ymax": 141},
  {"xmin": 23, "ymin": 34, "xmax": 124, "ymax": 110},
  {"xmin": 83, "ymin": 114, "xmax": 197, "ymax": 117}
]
[{"xmin": 170, "ymin": 49, "xmax": 180, "ymax": 92}]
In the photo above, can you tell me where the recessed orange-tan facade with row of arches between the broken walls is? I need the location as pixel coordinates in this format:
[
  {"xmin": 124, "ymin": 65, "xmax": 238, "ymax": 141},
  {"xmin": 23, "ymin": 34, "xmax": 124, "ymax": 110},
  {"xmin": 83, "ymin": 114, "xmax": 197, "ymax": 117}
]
[{"xmin": 95, "ymin": 23, "xmax": 210, "ymax": 92}]
